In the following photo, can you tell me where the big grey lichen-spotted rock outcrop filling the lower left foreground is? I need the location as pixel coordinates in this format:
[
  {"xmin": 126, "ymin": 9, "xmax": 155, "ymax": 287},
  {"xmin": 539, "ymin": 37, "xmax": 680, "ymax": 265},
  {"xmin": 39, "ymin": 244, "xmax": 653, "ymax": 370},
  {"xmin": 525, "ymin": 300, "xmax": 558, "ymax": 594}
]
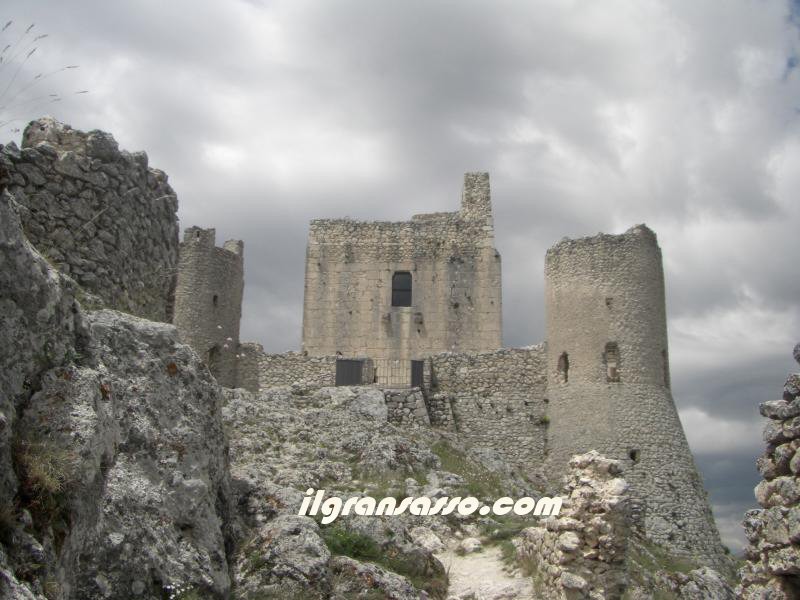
[{"xmin": 0, "ymin": 186, "xmax": 233, "ymax": 600}]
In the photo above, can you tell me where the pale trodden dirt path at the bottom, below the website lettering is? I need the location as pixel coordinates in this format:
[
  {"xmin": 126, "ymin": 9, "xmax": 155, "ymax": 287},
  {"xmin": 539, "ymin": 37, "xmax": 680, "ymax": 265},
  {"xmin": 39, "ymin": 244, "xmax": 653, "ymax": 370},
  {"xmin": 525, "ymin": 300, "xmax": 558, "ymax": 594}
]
[{"xmin": 436, "ymin": 546, "xmax": 534, "ymax": 600}]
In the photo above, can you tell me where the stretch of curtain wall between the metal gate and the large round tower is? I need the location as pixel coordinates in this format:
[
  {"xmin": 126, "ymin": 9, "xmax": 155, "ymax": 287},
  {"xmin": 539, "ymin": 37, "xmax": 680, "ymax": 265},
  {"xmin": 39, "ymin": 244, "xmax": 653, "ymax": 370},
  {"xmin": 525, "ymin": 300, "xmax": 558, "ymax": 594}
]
[{"xmin": 428, "ymin": 345, "xmax": 547, "ymax": 471}]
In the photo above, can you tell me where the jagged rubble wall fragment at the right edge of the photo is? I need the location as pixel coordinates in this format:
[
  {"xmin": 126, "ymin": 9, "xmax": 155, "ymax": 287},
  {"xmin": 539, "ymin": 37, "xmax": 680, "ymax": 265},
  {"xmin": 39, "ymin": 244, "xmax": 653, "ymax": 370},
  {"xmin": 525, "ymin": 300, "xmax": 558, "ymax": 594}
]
[{"xmin": 737, "ymin": 344, "xmax": 800, "ymax": 600}]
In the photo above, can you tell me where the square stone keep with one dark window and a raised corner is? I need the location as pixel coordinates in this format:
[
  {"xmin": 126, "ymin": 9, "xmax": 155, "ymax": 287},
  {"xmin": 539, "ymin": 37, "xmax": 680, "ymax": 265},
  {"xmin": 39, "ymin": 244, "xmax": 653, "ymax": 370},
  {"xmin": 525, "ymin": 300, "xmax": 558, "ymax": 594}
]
[{"xmin": 303, "ymin": 173, "xmax": 502, "ymax": 359}]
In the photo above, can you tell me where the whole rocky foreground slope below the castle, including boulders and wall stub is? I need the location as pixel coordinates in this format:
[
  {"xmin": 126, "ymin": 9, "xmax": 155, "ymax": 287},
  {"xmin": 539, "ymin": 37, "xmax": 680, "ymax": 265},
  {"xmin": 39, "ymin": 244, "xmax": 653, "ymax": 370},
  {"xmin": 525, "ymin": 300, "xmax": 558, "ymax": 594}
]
[{"xmin": 0, "ymin": 185, "xmax": 733, "ymax": 600}]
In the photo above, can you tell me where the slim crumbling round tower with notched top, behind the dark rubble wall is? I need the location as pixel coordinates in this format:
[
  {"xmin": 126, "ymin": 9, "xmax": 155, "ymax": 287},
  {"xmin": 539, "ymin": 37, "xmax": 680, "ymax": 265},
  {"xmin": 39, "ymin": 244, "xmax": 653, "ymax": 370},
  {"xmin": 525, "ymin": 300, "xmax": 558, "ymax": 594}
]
[{"xmin": 173, "ymin": 227, "xmax": 244, "ymax": 387}]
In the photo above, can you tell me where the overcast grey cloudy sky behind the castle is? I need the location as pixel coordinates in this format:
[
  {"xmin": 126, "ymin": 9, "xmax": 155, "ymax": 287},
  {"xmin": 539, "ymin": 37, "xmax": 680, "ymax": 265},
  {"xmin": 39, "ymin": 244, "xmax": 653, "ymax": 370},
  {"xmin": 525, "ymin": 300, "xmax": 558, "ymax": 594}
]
[{"xmin": 0, "ymin": 0, "xmax": 800, "ymax": 549}]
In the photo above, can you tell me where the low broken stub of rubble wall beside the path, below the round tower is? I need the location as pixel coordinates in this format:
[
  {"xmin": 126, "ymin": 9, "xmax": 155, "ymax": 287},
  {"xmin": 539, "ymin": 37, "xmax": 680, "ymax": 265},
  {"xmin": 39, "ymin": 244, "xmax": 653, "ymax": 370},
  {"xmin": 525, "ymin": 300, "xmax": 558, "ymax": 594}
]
[{"xmin": 517, "ymin": 452, "xmax": 630, "ymax": 600}]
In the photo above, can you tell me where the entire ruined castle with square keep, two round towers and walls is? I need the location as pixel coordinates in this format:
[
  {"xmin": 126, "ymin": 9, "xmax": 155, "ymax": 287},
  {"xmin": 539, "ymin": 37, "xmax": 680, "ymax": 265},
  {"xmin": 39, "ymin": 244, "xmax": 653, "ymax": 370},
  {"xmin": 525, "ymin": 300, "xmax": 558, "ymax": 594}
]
[{"xmin": 0, "ymin": 119, "xmax": 723, "ymax": 564}]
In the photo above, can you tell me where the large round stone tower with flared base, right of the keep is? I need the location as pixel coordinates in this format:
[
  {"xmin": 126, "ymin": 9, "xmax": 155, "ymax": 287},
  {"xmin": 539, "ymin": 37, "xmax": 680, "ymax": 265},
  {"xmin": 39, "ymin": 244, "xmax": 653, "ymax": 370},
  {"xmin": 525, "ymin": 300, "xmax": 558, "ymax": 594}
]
[{"xmin": 545, "ymin": 225, "xmax": 727, "ymax": 567}]
